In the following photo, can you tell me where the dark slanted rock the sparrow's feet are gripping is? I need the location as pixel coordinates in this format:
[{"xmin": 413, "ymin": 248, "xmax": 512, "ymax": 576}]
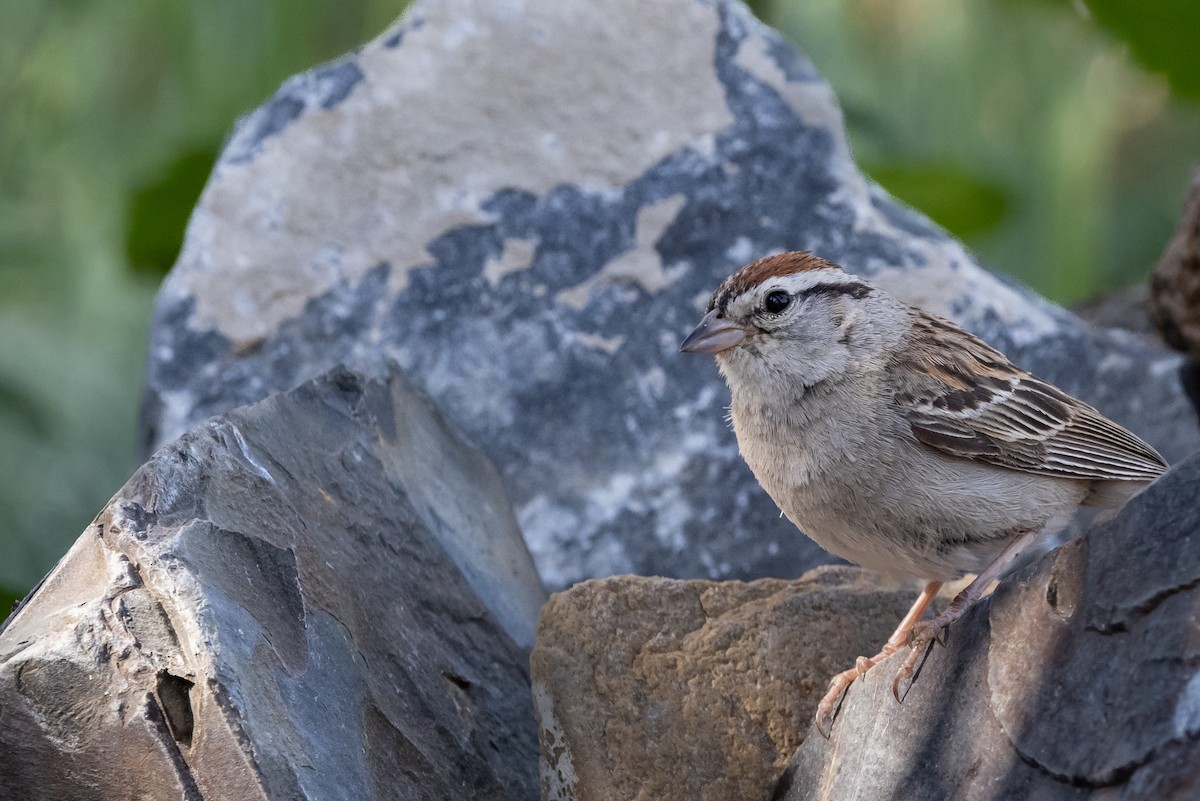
[{"xmin": 780, "ymin": 457, "xmax": 1200, "ymax": 801}]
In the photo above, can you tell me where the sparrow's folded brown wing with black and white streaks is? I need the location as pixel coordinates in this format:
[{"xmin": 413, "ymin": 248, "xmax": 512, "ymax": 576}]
[{"xmin": 892, "ymin": 312, "xmax": 1168, "ymax": 481}]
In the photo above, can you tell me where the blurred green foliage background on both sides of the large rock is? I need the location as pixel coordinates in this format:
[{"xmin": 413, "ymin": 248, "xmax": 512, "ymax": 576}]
[{"xmin": 0, "ymin": 0, "xmax": 1200, "ymax": 606}]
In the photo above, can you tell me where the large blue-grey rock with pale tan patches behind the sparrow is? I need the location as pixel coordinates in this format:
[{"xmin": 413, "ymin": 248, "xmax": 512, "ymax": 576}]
[{"xmin": 144, "ymin": 0, "xmax": 1200, "ymax": 588}]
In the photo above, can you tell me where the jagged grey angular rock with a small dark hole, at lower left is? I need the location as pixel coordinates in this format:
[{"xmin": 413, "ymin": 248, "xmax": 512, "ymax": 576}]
[{"xmin": 0, "ymin": 371, "xmax": 542, "ymax": 801}]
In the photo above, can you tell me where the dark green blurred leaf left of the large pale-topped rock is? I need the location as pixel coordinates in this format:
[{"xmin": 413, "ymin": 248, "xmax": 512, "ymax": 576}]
[{"xmin": 125, "ymin": 147, "xmax": 217, "ymax": 278}]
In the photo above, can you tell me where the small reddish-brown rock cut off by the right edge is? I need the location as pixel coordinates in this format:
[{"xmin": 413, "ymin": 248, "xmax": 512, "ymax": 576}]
[{"xmin": 1150, "ymin": 167, "xmax": 1200, "ymax": 361}]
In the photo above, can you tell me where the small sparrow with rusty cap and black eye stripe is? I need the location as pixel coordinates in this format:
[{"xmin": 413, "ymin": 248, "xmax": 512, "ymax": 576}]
[{"xmin": 680, "ymin": 253, "xmax": 1168, "ymax": 736}]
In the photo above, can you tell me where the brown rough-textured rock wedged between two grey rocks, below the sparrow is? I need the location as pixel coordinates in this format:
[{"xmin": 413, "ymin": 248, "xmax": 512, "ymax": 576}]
[{"xmin": 530, "ymin": 567, "xmax": 917, "ymax": 801}]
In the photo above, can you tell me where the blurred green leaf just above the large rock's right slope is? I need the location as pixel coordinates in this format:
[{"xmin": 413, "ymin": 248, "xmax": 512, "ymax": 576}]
[{"xmin": 864, "ymin": 163, "xmax": 1009, "ymax": 237}]
